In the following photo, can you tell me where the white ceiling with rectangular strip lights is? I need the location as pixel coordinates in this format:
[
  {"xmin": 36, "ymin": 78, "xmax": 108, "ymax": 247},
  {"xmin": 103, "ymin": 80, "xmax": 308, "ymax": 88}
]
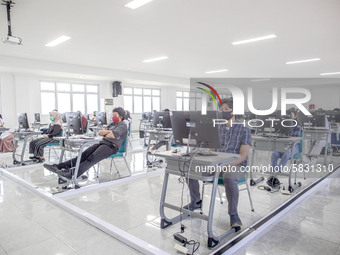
[{"xmin": 0, "ymin": 0, "xmax": 340, "ymax": 78}]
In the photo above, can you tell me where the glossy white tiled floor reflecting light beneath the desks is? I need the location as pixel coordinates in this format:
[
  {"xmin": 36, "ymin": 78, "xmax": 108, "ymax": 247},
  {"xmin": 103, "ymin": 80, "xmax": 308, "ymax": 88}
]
[{"xmin": 0, "ymin": 134, "xmax": 338, "ymax": 254}]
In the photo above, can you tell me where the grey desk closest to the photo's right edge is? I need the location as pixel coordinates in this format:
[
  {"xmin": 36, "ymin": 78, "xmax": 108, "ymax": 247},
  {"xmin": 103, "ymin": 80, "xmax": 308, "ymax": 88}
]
[{"xmin": 302, "ymin": 128, "xmax": 333, "ymax": 165}]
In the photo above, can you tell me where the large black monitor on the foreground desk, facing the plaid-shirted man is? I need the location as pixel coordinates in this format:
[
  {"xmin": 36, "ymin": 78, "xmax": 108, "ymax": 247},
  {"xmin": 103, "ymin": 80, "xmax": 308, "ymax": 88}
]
[{"xmin": 171, "ymin": 111, "xmax": 221, "ymax": 148}]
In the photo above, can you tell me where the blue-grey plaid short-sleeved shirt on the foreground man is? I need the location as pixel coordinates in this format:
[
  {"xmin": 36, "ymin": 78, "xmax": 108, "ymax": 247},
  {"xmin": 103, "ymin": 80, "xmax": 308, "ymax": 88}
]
[{"xmin": 217, "ymin": 123, "xmax": 251, "ymax": 166}]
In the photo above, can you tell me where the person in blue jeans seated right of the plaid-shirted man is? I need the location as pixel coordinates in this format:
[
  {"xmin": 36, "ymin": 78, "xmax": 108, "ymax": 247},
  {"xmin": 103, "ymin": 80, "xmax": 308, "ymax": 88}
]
[{"xmin": 271, "ymin": 108, "xmax": 301, "ymax": 172}]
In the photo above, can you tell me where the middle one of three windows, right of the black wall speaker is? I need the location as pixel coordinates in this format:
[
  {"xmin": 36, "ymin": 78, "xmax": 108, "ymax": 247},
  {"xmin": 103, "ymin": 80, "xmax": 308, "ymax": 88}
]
[{"xmin": 123, "ymin": 88, "xmax": 161, "ymax": 113}]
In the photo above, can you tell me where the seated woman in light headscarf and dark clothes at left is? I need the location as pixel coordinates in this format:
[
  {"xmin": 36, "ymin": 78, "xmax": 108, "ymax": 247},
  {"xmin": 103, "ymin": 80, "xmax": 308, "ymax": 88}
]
[{"xmin": 29, "ymin": 111, "xmax": 63, "ymax": 163}]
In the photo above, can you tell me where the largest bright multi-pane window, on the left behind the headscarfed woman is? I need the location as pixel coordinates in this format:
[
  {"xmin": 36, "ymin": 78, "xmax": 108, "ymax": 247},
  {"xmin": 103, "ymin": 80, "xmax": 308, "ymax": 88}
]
[{"xmin": 40, "ymin": 82, "xmax": 99, "ymax": 114}]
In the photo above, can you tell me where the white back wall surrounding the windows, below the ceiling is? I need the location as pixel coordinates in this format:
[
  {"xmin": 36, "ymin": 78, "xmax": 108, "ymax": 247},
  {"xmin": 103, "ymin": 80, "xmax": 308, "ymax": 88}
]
[{"xmin": 0, "ymin": 73, "xmax": 186, "ymax": 131}]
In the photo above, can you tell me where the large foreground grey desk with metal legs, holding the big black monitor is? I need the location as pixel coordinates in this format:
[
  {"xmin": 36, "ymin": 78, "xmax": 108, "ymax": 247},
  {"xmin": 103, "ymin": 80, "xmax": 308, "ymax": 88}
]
[{"xmin": 155, "ymin": 151, "xmax": 241, "ymax": 247}]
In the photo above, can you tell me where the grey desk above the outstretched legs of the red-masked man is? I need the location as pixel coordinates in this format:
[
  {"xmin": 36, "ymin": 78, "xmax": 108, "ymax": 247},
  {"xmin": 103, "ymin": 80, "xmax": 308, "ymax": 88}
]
[{"xmin": 56, "ymin": 137, "xmax": 102, "ymax": 189}]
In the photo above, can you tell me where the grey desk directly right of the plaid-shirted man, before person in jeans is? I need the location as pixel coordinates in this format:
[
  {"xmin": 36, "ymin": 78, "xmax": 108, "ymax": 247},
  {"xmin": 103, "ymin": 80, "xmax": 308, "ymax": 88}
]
[{"xmin": 250, "ymin": 136, "xmax": 301, "ymax": 192}]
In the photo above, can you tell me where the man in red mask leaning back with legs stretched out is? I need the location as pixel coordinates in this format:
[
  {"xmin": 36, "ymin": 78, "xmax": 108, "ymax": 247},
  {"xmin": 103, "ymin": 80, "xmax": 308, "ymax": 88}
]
[{"xmin": 44, "ymin": 107, "xmax": 127, "ymax": 179}]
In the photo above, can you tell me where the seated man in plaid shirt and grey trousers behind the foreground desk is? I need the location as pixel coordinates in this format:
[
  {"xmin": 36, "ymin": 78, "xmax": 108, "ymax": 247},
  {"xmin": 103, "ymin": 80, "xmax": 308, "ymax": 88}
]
[{"xmin": 184, "ymin": 97, "xmax": 251, "ymax": 228}]
